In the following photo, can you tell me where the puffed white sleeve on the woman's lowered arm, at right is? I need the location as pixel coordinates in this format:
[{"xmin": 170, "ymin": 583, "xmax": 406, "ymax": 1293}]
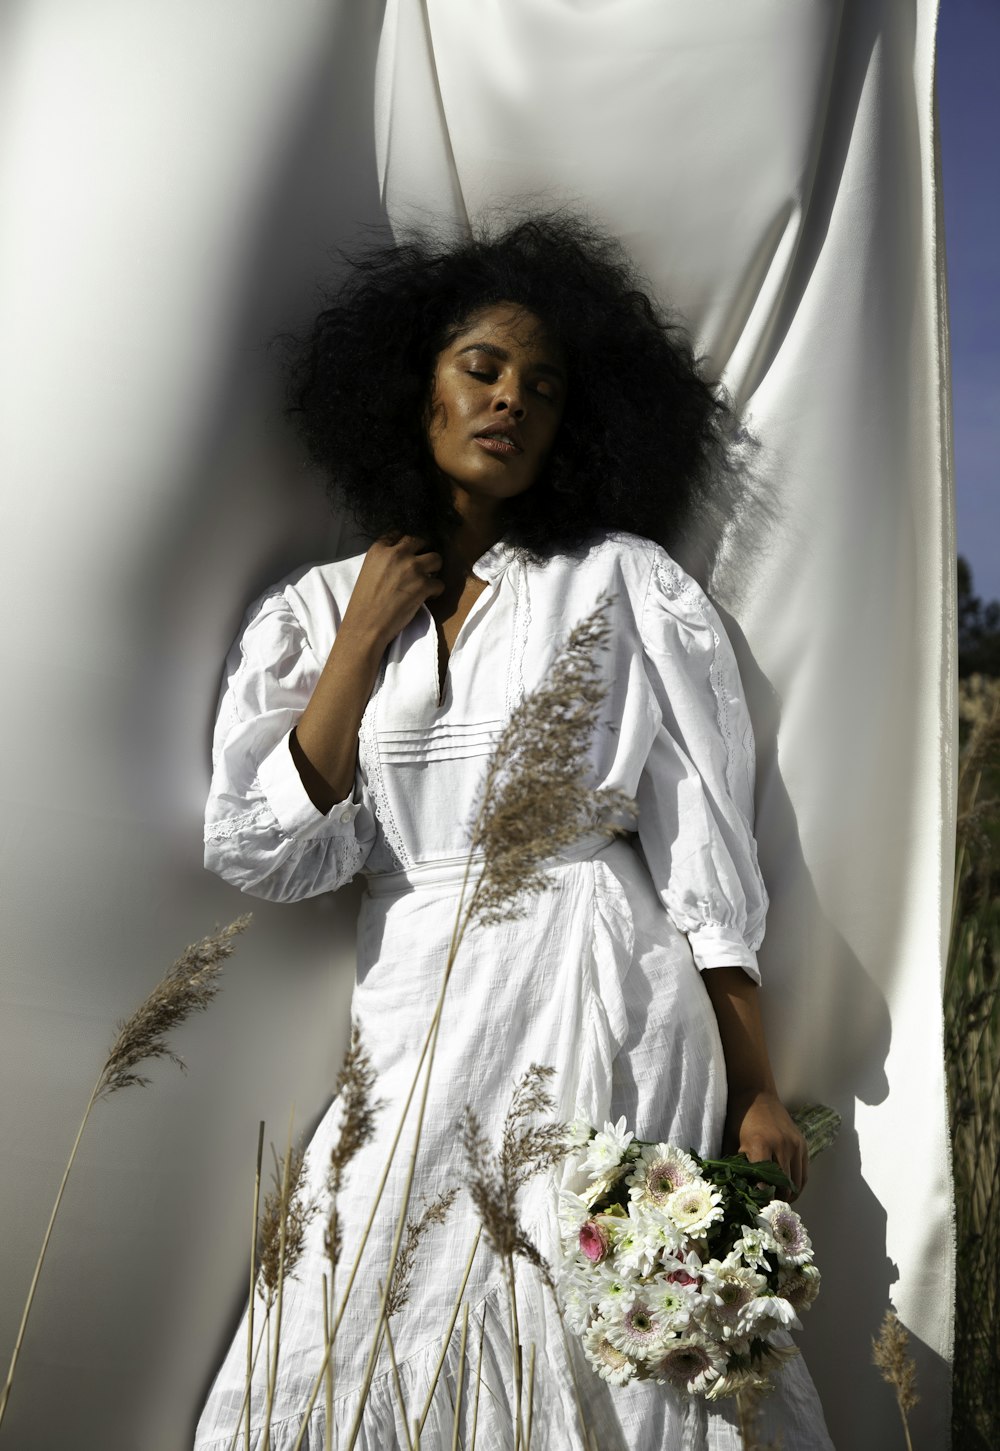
[{"xmin": 637, "ymin": 550, "xmax": 768, "ymax": 982}]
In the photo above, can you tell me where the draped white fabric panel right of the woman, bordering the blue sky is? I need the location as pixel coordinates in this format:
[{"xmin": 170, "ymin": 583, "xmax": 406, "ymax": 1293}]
[{"xmin": 376, "ymin": 0, "xmax": 955, "ymax": 1451}]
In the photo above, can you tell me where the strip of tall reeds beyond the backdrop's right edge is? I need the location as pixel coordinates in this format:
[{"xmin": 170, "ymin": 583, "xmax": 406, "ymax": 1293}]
[{"xmin": 945, "ymin": 676, "xmax": 1000, "ymax": 1451}]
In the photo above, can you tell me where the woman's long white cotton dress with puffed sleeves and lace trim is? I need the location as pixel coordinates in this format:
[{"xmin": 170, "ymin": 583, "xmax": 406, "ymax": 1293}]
[{"xmin": 196, "ymin": 534, "xmax": 830, "ymax": 1451}]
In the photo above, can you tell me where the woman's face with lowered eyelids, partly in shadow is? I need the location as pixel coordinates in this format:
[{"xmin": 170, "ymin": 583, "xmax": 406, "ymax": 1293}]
[{"xmin": 427, "ymin": 302, "xmax": 566, "ymax": 502}]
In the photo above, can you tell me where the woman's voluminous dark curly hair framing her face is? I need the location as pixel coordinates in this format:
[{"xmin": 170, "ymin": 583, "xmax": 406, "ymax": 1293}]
[{"xmin": 281, "ymin": 212, "xmax": 736, "ymax": 557}]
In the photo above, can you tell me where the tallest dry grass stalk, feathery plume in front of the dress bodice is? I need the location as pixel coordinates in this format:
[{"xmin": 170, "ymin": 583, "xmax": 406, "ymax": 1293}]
[{"xmin": 267, "ymin": 596, "xmax": 636, "ymax": 1451}]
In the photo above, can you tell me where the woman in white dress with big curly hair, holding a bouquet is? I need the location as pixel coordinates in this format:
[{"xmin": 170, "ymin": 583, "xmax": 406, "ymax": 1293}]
[{"xmin": 191, "ymin": 218, "xmax": 829, "ymax": 1451}]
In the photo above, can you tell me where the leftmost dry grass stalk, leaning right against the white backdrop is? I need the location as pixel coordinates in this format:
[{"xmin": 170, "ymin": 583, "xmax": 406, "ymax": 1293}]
[{"xmin": 0, "ymin": 914, "xmax": 250, "ymax": 1425}]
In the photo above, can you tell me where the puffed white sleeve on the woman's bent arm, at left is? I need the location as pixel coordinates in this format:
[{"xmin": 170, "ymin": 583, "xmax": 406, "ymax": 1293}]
[{"xmin": 205, "ymin": 591, "xmax": 374, "ymax": 901}]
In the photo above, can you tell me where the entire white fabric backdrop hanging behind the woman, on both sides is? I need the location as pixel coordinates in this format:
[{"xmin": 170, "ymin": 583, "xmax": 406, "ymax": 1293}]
[{"xmin": 0, "ymin": 0, "xmax": 954, "ymax": 1451}]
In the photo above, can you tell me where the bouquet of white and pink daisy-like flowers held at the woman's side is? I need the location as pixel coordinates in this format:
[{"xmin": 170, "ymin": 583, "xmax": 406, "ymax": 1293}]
[{"xmin": 557, "ymin": 1119, "xmax": 820, "ymax": 1400}]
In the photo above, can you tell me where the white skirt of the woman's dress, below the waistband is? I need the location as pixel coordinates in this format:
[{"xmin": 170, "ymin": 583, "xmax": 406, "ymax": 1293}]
[{"xmin": 194, "ymin": 839, "xmax": 830, "ymax": 1451}]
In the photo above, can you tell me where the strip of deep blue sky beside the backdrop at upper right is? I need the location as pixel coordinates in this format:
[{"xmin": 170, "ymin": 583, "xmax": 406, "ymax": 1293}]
[{"xmin": 938, "ymin": 0, "xmax": 1000, "ymax": 599}]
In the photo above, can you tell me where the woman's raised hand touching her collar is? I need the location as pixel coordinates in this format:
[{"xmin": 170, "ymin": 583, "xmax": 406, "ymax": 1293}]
[{"xmin": 341, "ymin": 534, "xmax": 444, "ymax": 650}]
